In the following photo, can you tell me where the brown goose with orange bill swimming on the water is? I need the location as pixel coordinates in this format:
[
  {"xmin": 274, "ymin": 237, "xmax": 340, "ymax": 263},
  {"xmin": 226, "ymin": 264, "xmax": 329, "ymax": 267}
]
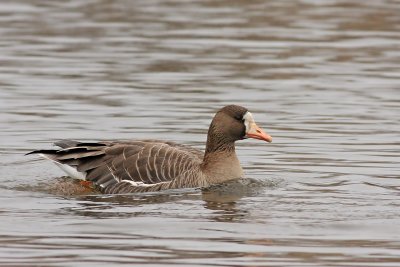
[{"xmin": 27, "ymin": 105, "xmax": 272, "ymax": 194}]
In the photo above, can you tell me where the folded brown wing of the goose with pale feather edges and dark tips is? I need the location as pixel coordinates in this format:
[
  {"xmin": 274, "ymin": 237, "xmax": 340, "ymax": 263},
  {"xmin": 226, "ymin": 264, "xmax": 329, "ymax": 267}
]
[{"xmin": 30, "ymin": 140, "xmax": 203, "ymax": 188}]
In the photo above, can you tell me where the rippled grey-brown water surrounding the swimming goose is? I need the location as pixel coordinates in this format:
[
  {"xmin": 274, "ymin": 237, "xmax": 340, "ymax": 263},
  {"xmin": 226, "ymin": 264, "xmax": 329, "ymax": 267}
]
[{"xmin": 0, "ymin": 0, "xmax": 400, "ymax": 266}]
